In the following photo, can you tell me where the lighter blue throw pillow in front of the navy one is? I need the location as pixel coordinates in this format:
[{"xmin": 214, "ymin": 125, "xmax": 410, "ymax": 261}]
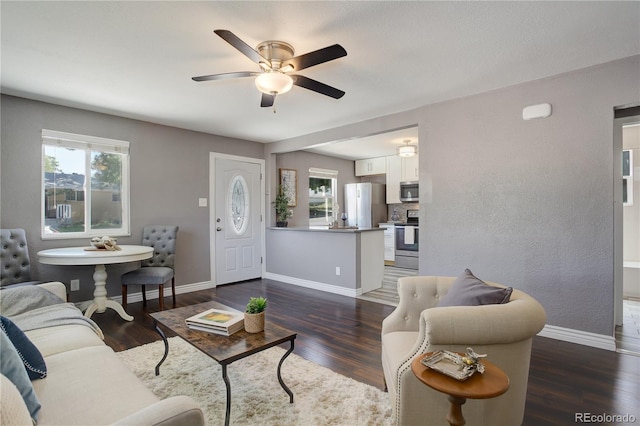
[{"xmin": 0, "ymin": 332, "xmax": 41, "ymax": 424}]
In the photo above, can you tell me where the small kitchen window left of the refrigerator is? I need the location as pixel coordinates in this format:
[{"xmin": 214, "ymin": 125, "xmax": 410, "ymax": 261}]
[{"xmin": 309, "ymin": 167, "xmax": 338, "ymax": 226}]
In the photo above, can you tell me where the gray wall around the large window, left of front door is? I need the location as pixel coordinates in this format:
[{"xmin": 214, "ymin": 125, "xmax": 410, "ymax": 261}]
[{"xmin": 0, "ymin": 95, "xmax": 264, "ymax": 301}]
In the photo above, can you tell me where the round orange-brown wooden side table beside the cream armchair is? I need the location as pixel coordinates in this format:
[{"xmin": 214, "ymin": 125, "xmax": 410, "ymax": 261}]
[{"xmin": 411, "ymin": 352, "xmax": 509, "ymax": 426}]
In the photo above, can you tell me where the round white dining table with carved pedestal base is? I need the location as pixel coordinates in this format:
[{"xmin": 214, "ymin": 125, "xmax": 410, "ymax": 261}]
[{"xmin": 38, "ymin": 245, "xmax": 153, "ymax": 321}]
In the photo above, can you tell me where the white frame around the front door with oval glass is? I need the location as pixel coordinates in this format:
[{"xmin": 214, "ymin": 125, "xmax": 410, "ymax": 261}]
[{"xmin": 209, "ymin": 152, "xmax": 267, "ymax": 287}]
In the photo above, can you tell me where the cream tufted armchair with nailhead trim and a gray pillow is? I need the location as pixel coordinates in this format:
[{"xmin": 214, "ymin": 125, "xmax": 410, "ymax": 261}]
[{"xmin": 382, "ymin": 276, "xmax": 546, "ymax": 426}]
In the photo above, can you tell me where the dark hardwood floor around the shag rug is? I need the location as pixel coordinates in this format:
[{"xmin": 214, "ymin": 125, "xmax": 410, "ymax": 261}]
[{"xmin": 92, "ymin": 280, "xmax": 640, "ymax": 426}]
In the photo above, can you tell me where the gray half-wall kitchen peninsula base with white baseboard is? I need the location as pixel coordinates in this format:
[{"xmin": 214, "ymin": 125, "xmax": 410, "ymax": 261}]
[{"xmin": 265, "ymin": 227, "xmax": 384, "ymax": 297}]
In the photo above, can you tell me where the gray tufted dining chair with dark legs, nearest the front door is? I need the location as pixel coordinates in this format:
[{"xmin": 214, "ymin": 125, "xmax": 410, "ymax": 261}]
[{"xmin": 121, "ymin": 225, "xmax": 178, "ymax": 311}]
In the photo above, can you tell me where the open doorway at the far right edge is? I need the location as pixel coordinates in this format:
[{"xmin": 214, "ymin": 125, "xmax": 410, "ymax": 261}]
[{"xmin": 614, "ymin": 106, "xmax": 640, "ymax": 354}]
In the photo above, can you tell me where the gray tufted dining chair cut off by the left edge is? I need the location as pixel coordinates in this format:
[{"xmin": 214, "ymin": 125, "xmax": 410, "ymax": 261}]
[{"xmin": 0, "ymin": 228, "xmax": 41, "ymax": 287}]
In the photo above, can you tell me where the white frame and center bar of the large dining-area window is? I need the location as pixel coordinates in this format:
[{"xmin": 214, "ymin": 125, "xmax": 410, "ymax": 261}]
[{"xmin": 40, "ymin": 129, "xmax": 131, "ymax": 240}]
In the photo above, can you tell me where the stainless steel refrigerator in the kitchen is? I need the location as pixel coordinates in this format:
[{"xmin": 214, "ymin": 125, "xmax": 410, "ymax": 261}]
[{"xmin": 340, "ymin": 182, "xmax": 387, "ymax": 228}]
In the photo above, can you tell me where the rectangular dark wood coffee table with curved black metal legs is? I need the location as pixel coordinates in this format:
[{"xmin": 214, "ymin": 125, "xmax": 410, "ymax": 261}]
[{"xmin": 149, "ymin": 301, "xmax": 296, "ymax": 426}]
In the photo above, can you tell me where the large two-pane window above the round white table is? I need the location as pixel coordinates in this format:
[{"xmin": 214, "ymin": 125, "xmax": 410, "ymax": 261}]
[{"xmin": 42, "ymin": 129, "xmax": 129, "ymax": 239}]
